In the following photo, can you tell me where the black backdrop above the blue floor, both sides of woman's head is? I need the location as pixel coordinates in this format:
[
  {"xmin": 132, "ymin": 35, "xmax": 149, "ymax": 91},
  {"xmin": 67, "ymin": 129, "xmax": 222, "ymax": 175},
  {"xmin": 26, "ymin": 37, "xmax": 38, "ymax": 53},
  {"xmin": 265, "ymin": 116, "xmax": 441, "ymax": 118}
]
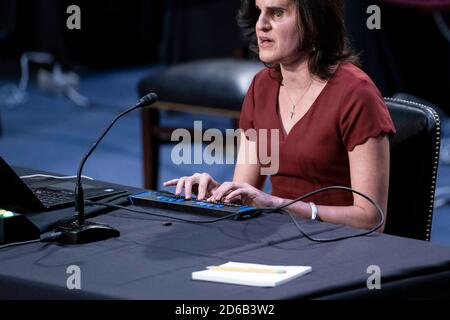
[{"xmin": 0, "ymin": 0, "xmax": 450, "ymax": 113}]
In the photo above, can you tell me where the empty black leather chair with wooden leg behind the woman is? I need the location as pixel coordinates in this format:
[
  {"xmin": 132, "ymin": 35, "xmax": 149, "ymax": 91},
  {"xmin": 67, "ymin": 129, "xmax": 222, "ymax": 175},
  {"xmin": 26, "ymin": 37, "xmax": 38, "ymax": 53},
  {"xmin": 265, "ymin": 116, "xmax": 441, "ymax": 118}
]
[{"xmin": 138, "ymin": 59, "xmax": 264, "ymax": 189}]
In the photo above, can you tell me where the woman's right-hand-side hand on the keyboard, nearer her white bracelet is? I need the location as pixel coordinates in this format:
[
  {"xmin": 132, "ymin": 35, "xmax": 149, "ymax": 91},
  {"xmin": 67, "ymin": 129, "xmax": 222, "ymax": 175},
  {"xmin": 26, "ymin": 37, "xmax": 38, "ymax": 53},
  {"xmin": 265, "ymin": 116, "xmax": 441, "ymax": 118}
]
[{"xmin": 208, "ymin": 182, "xmax": 283, "ymax": 207}]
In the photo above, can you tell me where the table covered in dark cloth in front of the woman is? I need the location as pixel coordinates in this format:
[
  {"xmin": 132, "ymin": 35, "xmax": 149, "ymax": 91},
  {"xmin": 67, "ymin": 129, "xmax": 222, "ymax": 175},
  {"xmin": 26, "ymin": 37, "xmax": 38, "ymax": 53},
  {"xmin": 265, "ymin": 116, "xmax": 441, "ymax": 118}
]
[{"xmin": 0, "ymin": 170, "xmax": 450, "ymax": 300}]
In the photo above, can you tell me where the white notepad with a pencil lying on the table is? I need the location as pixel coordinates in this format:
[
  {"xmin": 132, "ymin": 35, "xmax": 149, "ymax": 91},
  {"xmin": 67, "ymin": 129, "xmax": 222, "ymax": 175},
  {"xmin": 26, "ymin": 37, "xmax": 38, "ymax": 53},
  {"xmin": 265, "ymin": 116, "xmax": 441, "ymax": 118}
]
[{"xmin": 192, "ymin": 262, "xmax": 312, "ymax": 287}]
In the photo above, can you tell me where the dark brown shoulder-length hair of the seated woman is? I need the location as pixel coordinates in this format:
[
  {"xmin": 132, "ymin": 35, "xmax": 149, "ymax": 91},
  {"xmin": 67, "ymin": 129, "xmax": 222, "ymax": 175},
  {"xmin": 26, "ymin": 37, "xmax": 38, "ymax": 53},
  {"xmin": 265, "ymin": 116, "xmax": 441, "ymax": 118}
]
[{"xmin": 237, "ymin": 0, "xmax": 359, "ymax": 80}]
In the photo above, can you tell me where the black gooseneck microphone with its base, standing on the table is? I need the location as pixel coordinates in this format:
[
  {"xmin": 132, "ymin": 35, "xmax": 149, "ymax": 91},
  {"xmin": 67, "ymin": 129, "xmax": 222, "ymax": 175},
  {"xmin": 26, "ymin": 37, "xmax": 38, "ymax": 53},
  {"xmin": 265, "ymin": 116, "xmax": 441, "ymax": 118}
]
[{"xmin": 57, "ymin": 92, "xmax": 158, "ymax": 244}]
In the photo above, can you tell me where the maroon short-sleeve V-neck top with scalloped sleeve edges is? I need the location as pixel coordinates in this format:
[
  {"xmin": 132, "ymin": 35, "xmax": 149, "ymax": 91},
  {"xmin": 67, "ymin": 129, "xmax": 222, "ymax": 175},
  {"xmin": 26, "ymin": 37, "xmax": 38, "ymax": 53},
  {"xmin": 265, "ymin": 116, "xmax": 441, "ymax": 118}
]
[{"xmin": 240, "ymin": 63, "xmax": 395, "ymax": 206}]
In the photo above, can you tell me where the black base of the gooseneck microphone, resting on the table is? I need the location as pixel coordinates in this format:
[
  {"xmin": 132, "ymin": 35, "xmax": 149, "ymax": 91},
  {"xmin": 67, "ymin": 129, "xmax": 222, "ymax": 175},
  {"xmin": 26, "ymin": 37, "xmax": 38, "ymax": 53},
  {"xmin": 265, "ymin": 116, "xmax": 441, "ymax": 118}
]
[{"xmin": 56, "ymin": 221, "xmax": 120, "ymax": 244}]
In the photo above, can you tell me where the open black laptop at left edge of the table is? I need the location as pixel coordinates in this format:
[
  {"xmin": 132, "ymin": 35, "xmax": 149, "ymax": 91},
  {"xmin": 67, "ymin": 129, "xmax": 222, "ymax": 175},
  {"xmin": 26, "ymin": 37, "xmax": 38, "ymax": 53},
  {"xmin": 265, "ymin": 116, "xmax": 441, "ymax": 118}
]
[{"xmin": 0, "ymin": 157, "xmax": 126, "ymax": 212}]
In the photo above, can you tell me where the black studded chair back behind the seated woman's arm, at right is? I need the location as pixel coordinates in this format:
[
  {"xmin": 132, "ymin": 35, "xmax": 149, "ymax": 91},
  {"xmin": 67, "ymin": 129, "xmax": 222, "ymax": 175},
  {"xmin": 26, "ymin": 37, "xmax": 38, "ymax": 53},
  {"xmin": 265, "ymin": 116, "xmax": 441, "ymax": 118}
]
[{"xmin": 385, "ymin": 98, "xmax": 441, "ymax": 241}]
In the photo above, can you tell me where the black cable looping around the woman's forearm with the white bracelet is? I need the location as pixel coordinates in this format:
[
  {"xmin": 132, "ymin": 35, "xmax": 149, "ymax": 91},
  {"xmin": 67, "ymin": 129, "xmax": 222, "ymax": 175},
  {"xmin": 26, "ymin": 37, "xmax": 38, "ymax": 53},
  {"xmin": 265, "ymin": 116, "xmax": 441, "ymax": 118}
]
[{"xmin": 262, "ymin": 186, "xmax": 384, "ymax": 242}]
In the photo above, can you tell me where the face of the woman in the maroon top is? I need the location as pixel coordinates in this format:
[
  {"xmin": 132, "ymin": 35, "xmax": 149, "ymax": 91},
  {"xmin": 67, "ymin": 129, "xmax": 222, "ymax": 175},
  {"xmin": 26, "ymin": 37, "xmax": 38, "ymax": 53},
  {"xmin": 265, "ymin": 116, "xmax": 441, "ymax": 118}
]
[{"xmin": 256, "ymin": 0, "xmax": 301, "ymax": 65}]
